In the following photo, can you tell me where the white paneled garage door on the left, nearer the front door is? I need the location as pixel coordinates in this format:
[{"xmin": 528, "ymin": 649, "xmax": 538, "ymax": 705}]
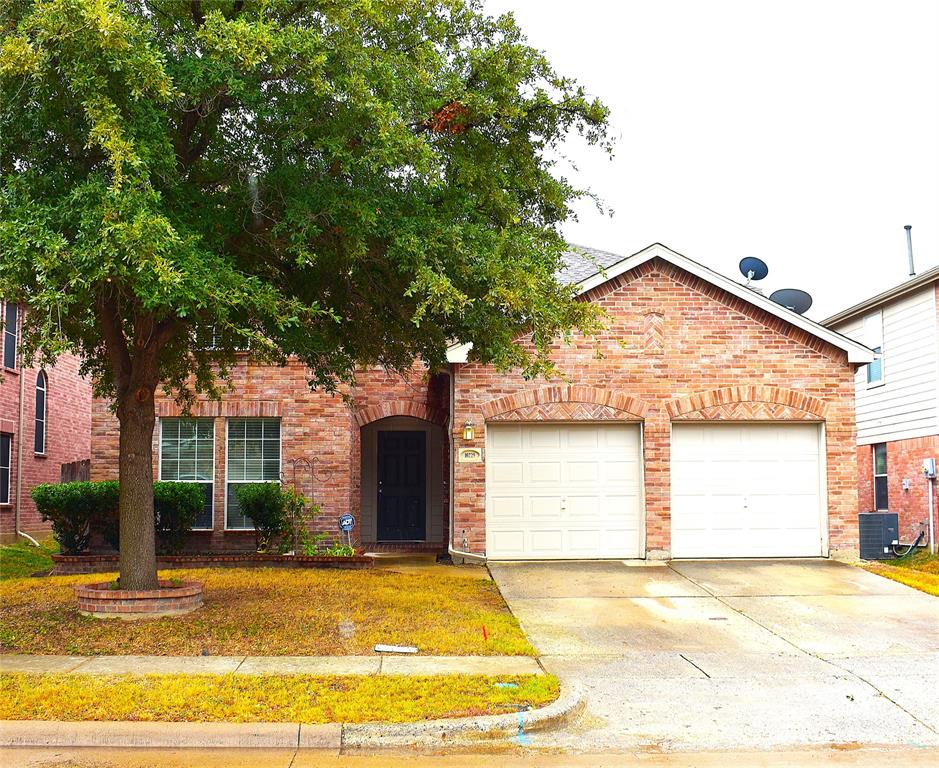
[{"xmin": 486, "ymin": 424, "xmax": 642, "ymax": 560}]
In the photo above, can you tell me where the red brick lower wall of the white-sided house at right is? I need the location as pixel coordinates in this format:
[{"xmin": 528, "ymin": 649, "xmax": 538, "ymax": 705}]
[{"xmin": 857, "ymin": 435, "xmax": 939, "ymax": 544}]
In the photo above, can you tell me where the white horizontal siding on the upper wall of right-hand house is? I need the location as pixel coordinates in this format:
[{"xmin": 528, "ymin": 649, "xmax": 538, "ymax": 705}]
[{"xmin": 834, "ymin": 285, "xmax": 939, "ymax": 445}]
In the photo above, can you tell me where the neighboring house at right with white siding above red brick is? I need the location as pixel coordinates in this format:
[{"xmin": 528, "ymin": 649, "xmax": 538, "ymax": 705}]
[{"xmin": 823, "ymin": 267, "xmax": 939, "ymax": 542}]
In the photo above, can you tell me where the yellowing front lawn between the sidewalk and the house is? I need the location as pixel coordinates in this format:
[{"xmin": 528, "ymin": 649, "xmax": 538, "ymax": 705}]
[{"xmin": 0, "ymin": 565, "xmax": 535, "ymax": 656}]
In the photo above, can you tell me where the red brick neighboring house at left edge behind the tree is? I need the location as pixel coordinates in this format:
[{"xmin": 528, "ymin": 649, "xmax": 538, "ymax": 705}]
[{"xmin": 0, "ymin": 299, "xmax": 91, "ymax": 541}]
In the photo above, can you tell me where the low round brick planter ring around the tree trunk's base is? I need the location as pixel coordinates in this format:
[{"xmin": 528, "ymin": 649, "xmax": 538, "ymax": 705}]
[{"xmin": 75, "ymin": 579, "xmax": 202, "ymax": 619}]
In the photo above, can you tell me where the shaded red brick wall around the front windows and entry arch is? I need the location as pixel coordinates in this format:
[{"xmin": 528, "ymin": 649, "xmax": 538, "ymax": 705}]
[{"xmin": 92, "ymin": 363, "xmax": 449, "ymax": 551}]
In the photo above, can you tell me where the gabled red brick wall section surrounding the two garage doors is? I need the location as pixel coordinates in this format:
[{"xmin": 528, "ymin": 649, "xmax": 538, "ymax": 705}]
[{"xmin": 453, "ymin": 259, "xmax": 857, "ymax": 556}]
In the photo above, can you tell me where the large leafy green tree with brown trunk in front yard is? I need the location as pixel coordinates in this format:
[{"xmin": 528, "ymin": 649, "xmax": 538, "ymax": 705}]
[{"xmin": 0, "ymin": 0, "xmax": 609, "ymax": 588}]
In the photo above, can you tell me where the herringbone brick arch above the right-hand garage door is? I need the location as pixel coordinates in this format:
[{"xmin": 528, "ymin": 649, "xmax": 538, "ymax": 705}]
[{"xmin": 665, "ymin": 385, "xmax": 828, "ymax": 421}]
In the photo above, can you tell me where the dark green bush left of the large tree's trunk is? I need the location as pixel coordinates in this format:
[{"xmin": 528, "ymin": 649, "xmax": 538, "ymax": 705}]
[{"xmin": 30, "ymin": 481, "xmax": 118, "ymax": 555}]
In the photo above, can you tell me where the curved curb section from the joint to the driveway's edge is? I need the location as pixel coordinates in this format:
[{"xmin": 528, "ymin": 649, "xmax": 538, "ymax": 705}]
[{"xmin": 342, "ymin": 685, "xmax": 586, "ymax": 749}]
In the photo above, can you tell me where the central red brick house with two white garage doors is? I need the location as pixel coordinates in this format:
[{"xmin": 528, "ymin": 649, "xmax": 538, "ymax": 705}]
[{"xmin": 92, "ymin": 244, "xmax": 873, "ymax": 559}]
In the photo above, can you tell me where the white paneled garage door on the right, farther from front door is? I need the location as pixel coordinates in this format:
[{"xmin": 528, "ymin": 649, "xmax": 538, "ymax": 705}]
[{"xmin": 672, "ymin": 423, "xmax": 824, "ymax": 558}]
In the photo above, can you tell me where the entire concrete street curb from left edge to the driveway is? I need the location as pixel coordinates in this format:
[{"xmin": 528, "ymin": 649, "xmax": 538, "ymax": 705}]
[{"xmin": 0, "ymin": 686, "xmax": 585, "ymax": 753}]
